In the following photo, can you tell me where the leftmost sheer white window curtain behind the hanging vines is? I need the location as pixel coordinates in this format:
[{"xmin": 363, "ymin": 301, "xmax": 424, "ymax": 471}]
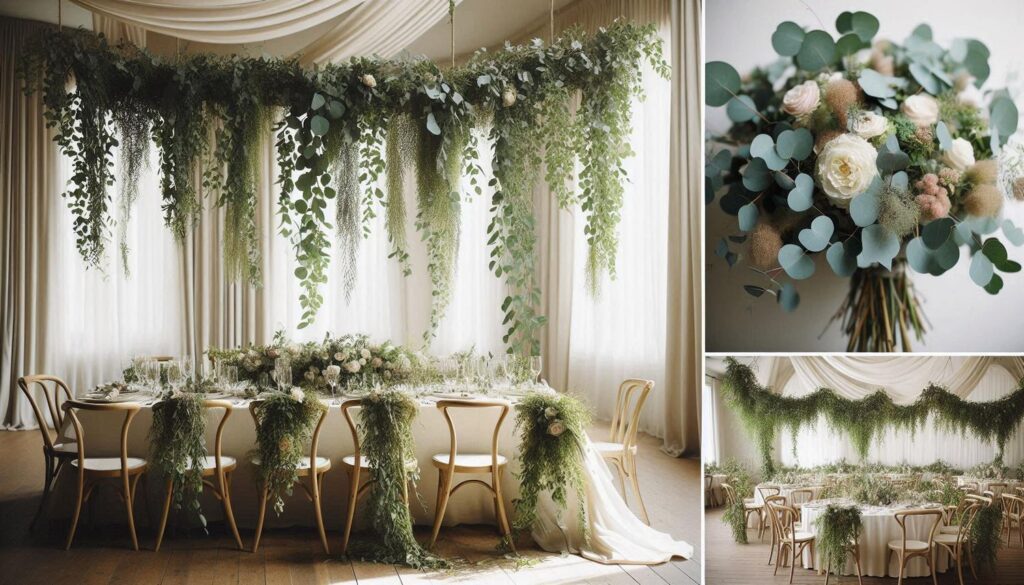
[{"xmin": 40, "ymin": 148, "xmax": 183, "ymax": 392}]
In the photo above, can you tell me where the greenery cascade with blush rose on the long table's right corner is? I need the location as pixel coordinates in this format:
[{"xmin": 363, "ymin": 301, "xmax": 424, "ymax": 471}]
[{"xmin": 512, "ymin": 392, "xmax": 590, "ymax": 542}]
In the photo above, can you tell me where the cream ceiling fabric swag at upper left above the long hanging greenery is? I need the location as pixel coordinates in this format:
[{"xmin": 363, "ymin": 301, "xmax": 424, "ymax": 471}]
[{"xmin": 72, "ymin": 0, "xmax": 365, "ymax": 44}]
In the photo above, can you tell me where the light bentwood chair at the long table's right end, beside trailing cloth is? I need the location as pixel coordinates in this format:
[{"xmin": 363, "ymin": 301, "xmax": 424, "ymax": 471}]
[{"xmin": 592, "ymin": 378, "xmax": 654, "ymax": 525}]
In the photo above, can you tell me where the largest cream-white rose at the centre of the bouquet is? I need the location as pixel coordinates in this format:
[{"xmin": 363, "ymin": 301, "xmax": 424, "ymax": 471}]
[{"xmin": 817, "ymin": 134, "xmax": 879, "ymax": 208}]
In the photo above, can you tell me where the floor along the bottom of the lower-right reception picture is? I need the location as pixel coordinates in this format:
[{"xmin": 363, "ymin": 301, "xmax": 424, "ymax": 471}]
[{"xmin": 705, "ymin": 508, "xmax": 1024, "ymax": 585}]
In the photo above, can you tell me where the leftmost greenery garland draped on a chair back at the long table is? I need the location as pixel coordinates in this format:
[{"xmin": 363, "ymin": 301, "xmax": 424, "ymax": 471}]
[{"xmin": 148, "ymin": 391, "xmax": 206, "ymax": 527}]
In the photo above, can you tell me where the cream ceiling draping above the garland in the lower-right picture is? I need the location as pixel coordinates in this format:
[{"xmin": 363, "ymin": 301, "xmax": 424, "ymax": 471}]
[{"xmin": 768, "ymin": 356, "xmax": 1024, "ymax": 405}]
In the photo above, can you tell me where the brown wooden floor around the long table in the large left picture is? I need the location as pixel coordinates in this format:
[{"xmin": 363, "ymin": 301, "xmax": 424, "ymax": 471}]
[{"xmin": 0, "ymin": 428, "xmax": 702, "ymax": 585}]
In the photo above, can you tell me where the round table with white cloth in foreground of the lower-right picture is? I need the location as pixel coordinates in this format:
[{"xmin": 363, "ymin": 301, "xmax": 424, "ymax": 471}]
[{"xmin": 800, "ymin": 500, "xmax": 949, "ymax": 577}]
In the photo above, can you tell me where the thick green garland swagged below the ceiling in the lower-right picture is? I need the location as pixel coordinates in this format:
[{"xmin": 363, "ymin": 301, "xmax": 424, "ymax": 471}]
[{"xmin": 722, "ymin": 358, "xmax": 1024, "ymax": 476}]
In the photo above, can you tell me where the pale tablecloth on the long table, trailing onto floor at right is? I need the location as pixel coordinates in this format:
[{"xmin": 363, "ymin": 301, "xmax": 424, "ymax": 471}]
[{"xmin": 51, "ymin": 391, "xmax": 693, "ymax": 563}]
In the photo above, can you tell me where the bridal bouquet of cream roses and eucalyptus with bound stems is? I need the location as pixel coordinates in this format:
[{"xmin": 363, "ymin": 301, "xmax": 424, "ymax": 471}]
[{"xmin": 705, "ymin": 12, "xmax": 1024, "ymax": 351}]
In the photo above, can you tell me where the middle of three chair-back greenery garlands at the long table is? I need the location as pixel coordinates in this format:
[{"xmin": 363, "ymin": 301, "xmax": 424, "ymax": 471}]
[{"xmin": 253, "ymin": 388, "xmax": 327, "ymax": 514}]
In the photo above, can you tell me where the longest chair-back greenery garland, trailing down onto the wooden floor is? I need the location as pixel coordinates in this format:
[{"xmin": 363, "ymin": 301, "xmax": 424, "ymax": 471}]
[{"xmin": 352, "ymin": 390, "xmax": 449, "ymax": 569}]
